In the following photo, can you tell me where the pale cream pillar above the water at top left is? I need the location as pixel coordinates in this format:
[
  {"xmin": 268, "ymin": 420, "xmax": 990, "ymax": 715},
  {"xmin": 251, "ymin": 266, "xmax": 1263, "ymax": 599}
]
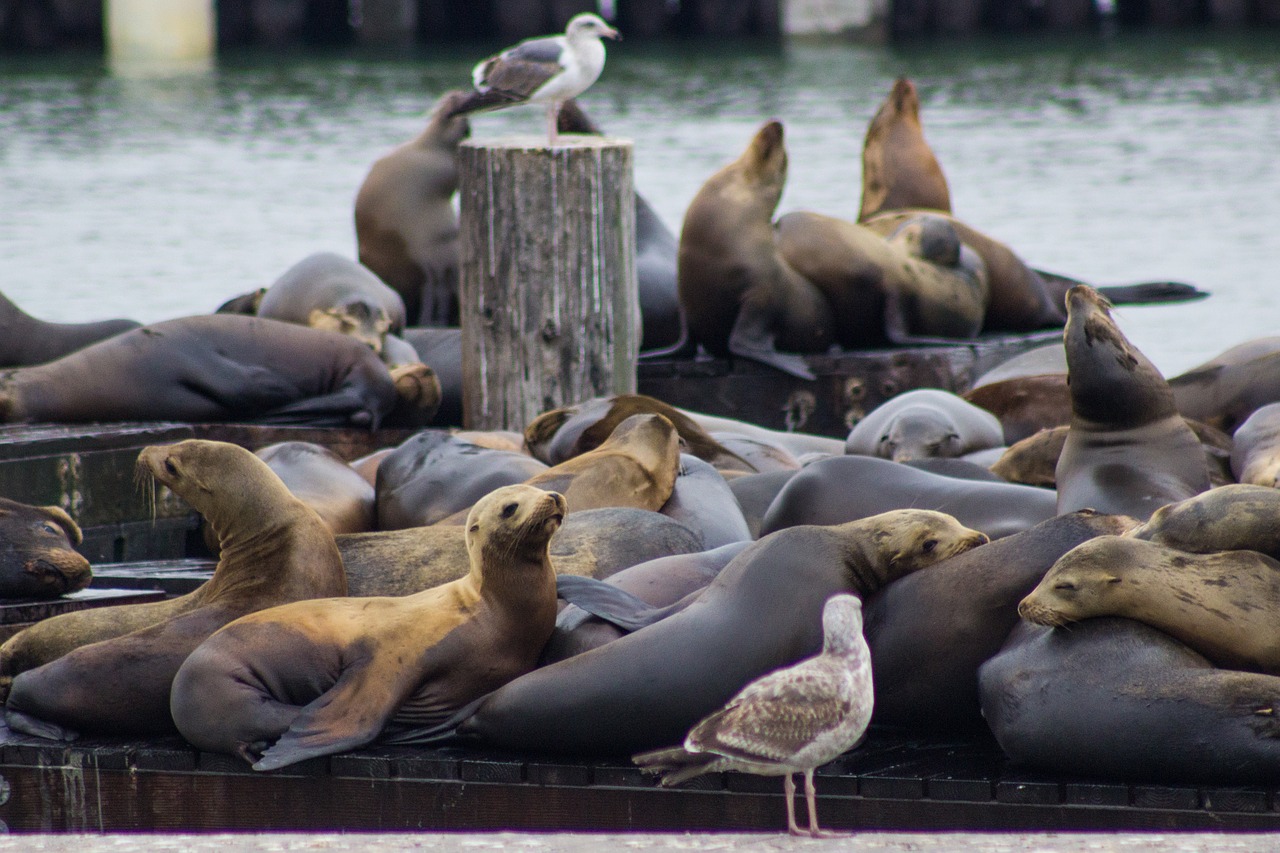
[{"xmin": 106, "ymin": 0, "xmax": 218, "ymax": 68}]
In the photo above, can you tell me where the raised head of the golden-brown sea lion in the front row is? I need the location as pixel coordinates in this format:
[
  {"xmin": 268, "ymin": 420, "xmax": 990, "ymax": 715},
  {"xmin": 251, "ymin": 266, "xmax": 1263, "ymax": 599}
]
[{"xmin": 466, "ymin": 484, "xmax": 568, "ymax": 566}]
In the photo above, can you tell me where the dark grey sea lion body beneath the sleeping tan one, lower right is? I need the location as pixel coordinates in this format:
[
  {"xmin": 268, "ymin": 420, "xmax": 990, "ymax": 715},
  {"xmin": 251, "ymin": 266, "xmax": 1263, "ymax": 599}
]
[{"xmin": 978, "ymin": 617, "xmax": 1280, "ymax": 786}]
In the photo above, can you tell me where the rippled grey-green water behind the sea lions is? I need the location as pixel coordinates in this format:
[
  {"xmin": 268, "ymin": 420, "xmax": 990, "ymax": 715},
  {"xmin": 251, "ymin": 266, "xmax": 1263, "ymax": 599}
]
[{"xmin": 0, "ymin": 33, "xmax": 1280, "ymax": 375}]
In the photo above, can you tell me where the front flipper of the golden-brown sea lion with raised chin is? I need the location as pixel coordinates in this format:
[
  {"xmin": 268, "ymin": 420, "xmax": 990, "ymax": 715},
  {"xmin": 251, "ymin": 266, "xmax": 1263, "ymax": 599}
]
[{"xmin": 253, "ymin": 660, "xmax": 403, "ymax": 770}]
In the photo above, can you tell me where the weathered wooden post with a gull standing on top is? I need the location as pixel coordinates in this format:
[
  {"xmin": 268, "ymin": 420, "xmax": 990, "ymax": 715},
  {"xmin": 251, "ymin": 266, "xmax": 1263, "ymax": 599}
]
[{"xmin": 458, "ymin": 136, "xmax": 640, "ymax": 430}]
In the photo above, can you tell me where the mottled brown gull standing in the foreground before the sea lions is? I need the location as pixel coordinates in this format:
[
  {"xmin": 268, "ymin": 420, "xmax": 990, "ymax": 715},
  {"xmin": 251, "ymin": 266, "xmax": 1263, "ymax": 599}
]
[{"xmin": 632, "ymin": 594, "xmax": 874, "ymax": 838}]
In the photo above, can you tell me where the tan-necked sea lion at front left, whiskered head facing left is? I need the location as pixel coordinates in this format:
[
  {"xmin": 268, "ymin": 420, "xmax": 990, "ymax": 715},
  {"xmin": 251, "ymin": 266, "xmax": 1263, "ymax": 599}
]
[{"xmin": 0, "ymin": 439, "xmax": 347, "ymax": 738}]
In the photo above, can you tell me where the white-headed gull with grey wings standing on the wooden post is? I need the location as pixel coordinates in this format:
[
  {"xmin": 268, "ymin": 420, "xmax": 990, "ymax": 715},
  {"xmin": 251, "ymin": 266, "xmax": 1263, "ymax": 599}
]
[{"xmin": 452, "ymin": 12, "xmax": 621, "ymax": 145}]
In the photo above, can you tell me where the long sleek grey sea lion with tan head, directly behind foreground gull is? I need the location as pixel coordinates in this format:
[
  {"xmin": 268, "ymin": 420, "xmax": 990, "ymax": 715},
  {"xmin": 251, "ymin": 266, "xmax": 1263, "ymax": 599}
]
[{"xmin": 389, "ymin": 510, "xmax": 987, "ymax": 757}]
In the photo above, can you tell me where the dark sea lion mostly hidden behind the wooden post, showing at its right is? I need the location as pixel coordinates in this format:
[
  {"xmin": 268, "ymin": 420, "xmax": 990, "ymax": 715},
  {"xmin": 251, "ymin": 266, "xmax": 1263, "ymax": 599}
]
[{"xmin": 556, "ymin": 99, "xmax": 685, "ymax": 353}]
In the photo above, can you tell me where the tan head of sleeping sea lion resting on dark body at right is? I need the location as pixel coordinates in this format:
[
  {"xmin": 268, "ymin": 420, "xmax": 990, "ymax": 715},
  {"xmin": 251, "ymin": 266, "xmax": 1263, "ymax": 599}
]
[{"xmin": 1018, "ymin": 535, "xmax": 1141, "ymax": 628}]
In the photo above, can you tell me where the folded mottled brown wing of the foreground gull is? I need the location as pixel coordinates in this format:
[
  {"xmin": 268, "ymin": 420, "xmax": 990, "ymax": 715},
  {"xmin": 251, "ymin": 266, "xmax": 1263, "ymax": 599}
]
[{"xmin": 685, "ymin": 666, "xmax": 855, "ymax": 763}]
